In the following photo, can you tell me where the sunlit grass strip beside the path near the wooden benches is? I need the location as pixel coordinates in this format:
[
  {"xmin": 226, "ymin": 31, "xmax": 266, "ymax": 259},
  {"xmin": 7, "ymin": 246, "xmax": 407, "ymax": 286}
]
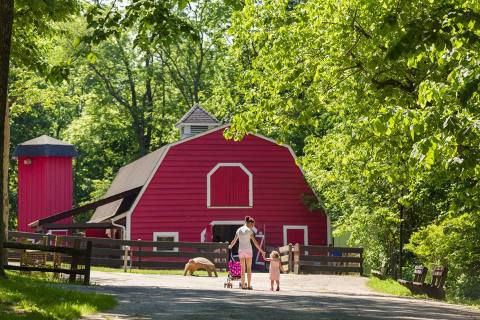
[{"xmin": 367, "ymin": 277, "xmax": 480, "ymax": 308}]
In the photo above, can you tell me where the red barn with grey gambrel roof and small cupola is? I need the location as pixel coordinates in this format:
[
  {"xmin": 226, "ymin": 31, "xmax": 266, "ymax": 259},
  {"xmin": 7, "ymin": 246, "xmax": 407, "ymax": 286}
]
[{"xmin": 90, "ymin": 105, "xmax": 329, "ymax": 255}]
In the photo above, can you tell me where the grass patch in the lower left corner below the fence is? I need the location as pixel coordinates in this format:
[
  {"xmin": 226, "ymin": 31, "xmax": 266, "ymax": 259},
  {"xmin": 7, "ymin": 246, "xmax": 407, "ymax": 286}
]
[{"xmin": 0, "ymin": 272, "xmax": 116, "ymax": 320}]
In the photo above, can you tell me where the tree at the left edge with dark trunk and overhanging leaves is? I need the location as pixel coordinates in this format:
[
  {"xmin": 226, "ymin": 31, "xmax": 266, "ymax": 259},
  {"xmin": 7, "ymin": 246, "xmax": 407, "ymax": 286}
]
[{"xmin": 0, "ymin": 0, "xmax": 78, "ymax": 276}]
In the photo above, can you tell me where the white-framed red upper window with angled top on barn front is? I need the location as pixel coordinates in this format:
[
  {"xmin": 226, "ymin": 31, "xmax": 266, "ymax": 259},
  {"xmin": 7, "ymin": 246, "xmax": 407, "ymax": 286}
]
[{"xmin": 207, "ymin": 163, "xmax": 253, "ymax": 208}]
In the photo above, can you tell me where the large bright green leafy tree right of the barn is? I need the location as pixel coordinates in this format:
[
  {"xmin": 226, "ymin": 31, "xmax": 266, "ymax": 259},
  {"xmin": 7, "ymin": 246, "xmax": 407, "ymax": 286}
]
[{"xmin": 217, "ymin": 0, "xmax": 480, "ymax": 296}]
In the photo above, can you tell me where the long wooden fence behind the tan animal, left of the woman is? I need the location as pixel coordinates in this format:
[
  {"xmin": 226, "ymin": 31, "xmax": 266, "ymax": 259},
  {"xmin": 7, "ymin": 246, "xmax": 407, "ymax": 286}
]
[{"xmin": 9, "ymin": 231, "xmax": 228, "ymax": 269}]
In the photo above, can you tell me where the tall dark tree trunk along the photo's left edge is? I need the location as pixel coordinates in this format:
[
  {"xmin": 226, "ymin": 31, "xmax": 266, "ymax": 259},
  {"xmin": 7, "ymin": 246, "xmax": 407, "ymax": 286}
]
[{"xmin": 0, "ymin": 0, "xmax": 13, "ymax": 277}]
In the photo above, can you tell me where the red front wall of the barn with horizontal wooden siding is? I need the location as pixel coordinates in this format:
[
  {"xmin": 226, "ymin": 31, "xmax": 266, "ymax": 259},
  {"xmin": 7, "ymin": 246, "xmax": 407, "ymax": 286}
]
[{"xmin": 131, "ymin": 130, "xmax": 327, "ymax": 246}]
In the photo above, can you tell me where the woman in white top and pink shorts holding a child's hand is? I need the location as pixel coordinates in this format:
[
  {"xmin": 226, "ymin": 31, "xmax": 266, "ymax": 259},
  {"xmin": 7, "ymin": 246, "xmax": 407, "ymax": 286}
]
[{"xmin": 228, "ymin": 216, "xmax": 265, "ymax": 290}]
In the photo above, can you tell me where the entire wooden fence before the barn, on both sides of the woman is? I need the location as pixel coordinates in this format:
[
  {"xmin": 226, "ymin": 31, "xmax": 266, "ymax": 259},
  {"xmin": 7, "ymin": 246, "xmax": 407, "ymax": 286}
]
[{"xmin": 9, "ymin": 231, "xmax": 363, "ymax": 274}]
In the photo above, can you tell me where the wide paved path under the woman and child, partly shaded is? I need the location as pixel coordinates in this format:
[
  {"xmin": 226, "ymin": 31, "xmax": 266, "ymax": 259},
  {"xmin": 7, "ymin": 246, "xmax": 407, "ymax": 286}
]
[{"xmin": 85, "ymin": 272, "xmax": 480, "ymax": 320}]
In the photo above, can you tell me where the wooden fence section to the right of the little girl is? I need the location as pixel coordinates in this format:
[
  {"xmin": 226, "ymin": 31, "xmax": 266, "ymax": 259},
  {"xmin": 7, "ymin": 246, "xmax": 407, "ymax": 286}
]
[{"xmin": 278, "ymin": 244, "xmax": 363, "ymax": 275}]
